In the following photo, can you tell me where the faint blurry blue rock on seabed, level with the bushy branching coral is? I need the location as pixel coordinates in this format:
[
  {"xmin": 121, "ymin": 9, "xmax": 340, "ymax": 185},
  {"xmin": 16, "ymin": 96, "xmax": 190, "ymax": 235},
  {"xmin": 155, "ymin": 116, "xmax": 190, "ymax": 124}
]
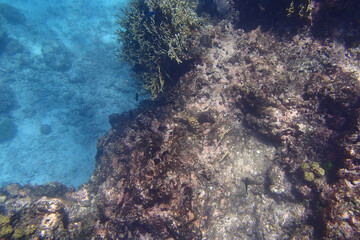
[{"xmin": 41, "ymin": 41, "xmax": 72, "ymax": 72}]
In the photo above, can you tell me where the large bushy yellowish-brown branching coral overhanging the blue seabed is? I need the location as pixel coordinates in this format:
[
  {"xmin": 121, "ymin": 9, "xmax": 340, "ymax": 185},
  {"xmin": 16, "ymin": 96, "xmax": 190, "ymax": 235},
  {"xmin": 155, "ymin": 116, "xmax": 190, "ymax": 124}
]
[{"xmin": 117, "ymin": 0, "xmax": 202, "ymax": 99}]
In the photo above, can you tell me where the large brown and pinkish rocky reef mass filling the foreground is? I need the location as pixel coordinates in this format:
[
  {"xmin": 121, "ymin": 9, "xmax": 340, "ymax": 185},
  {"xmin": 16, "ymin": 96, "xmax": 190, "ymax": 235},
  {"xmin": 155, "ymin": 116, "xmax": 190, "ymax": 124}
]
[{"xmin": 0, "ymin": 0, "xmax": 360, "ymax": 239}]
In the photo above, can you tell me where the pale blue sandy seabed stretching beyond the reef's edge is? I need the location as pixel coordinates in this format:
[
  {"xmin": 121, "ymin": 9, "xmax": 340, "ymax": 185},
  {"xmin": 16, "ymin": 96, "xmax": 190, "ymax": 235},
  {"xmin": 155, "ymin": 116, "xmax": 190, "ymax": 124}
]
[{"xmin": 0, "ymin": 0, "xmax": 136, "ymax": 187}]
